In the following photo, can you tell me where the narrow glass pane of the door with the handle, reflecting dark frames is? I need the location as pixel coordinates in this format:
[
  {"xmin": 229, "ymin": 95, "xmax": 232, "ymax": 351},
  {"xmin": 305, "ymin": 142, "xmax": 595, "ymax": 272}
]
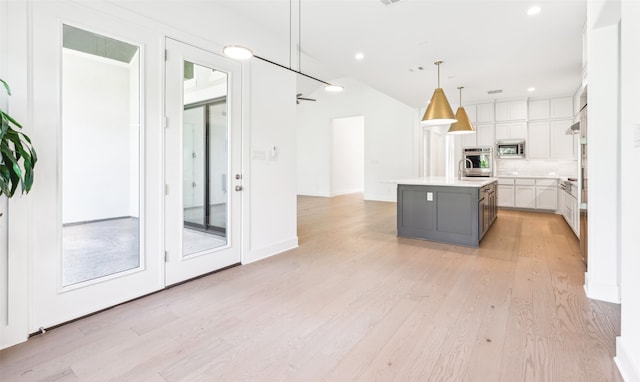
[{"xmin": 182, "ymin": 61, "xmax": 229, "ymax": 255}]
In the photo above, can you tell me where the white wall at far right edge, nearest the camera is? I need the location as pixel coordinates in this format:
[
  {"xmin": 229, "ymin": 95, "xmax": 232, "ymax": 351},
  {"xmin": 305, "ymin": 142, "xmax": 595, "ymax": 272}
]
[{"xmin": 616, "ymin": 1, "xmax": 640, "ymax": 381}]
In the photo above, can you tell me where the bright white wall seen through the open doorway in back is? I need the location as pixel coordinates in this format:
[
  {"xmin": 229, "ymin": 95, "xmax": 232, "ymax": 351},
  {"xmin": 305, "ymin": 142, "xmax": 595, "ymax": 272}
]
[{"xmin": 331, "ymin": 116, "xmax": 365, "ymax": 196}]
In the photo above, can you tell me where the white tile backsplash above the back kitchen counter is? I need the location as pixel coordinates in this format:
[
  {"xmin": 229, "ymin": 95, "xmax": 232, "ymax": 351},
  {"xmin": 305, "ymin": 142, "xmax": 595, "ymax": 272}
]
[{"xmin": 494, "ymin": 159, "xmax": 578, "ymax": 178}]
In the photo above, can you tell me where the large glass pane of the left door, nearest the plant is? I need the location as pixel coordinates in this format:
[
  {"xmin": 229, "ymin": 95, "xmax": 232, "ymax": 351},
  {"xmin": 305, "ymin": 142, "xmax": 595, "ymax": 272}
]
[{"xmin": 62, "ymin": 25, "xmax": 141, "ymax": 286}]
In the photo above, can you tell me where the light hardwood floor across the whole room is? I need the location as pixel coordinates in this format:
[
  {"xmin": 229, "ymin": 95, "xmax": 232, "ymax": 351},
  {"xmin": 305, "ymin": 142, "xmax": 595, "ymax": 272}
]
[{"xmin": 0, "ymin": 195, "xmax": 622, "ymax": 382}]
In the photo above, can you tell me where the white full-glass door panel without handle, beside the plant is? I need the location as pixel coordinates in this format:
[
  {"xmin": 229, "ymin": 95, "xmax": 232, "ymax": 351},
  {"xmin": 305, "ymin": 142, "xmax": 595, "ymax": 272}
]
[{"xmin": 29, "ymin": 2, "xmax": 165, "ymax": 332}]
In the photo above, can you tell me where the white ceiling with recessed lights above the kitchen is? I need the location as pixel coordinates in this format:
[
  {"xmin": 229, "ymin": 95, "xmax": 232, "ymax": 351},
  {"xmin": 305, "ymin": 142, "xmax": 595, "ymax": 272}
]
[{"xmin": 216, "ymin": 0, "xmax": 586, "ymax": 107}]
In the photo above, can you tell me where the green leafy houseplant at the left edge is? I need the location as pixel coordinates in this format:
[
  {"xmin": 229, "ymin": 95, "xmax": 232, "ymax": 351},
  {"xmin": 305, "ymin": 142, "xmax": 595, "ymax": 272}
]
[{"xmin": 0, "ymin": 79, "xmax": 38, "ymax": 198}]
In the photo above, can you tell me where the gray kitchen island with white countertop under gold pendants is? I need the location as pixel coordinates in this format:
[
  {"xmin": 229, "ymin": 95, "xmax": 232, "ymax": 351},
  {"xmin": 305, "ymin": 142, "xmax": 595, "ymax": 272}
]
[{"xmin": 393, "ymin": 177, "xmax": 498, "ymax": 247}]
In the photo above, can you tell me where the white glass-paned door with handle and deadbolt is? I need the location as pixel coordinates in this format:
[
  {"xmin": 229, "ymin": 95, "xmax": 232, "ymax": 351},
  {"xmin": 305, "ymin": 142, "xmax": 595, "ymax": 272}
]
[{"xmin": 165, "ymin": 38, "xmax": 242, "ymax": 285}]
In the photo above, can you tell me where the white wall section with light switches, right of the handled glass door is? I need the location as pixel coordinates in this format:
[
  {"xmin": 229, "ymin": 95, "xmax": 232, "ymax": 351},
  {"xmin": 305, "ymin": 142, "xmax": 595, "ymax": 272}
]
[{"xmin": 242, "ymin": 60, "xmax": 298, "ymax": 264}]
